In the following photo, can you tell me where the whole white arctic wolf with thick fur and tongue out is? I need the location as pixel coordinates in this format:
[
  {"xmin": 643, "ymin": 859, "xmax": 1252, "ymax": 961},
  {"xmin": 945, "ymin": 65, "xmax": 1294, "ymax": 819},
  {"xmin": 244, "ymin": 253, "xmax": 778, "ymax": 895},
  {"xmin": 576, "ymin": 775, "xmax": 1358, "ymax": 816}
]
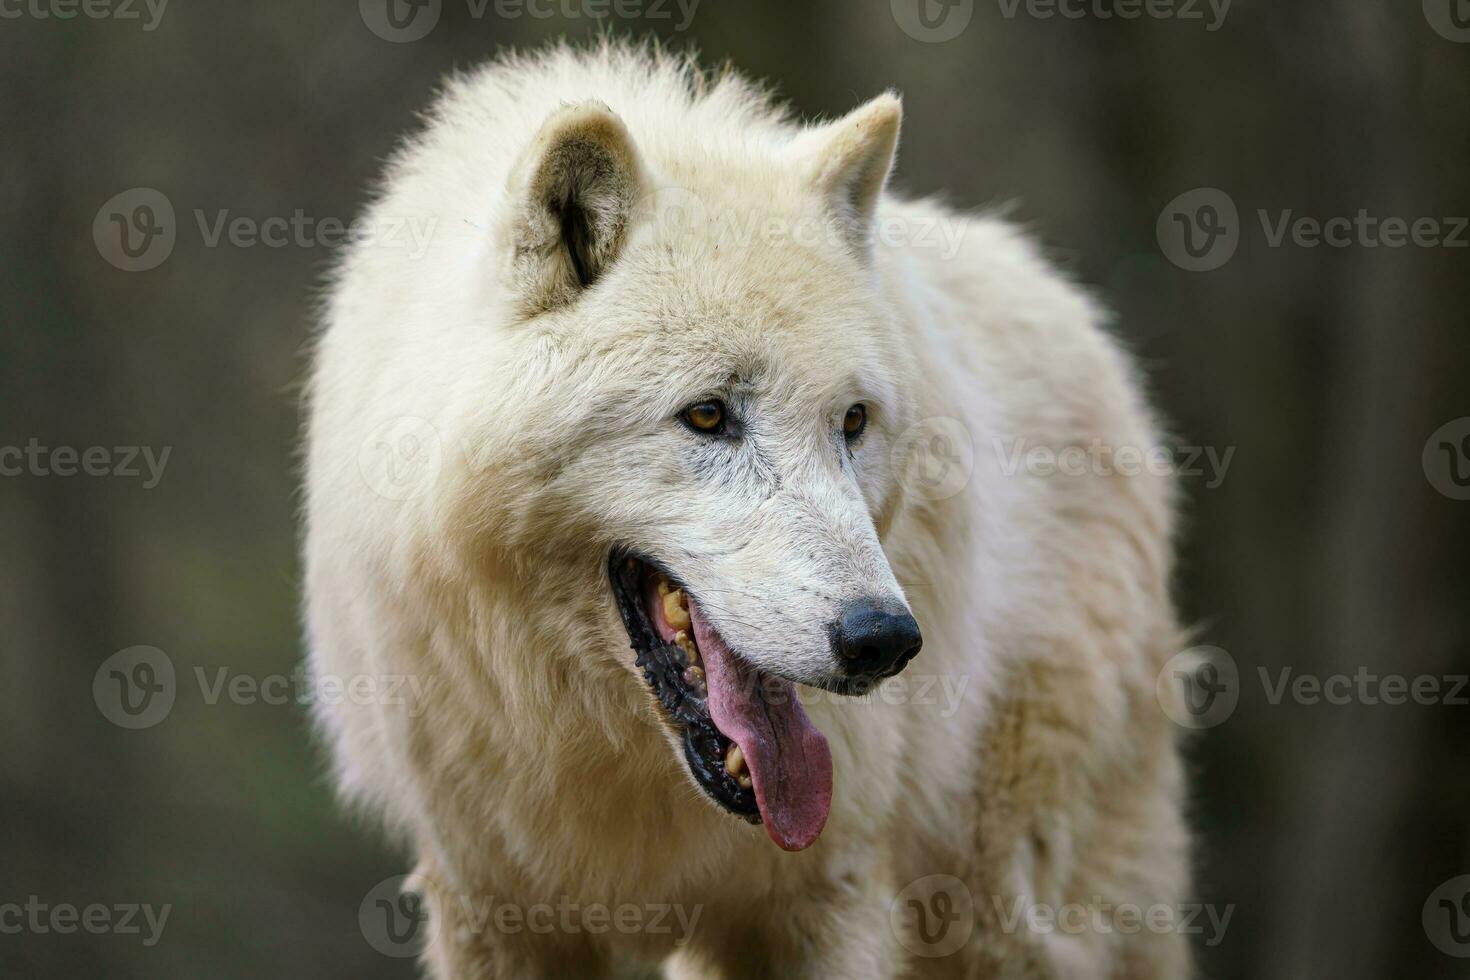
[{"xmin": 304, "ymin": 44, "xmax": 1188, "ymax": 980}]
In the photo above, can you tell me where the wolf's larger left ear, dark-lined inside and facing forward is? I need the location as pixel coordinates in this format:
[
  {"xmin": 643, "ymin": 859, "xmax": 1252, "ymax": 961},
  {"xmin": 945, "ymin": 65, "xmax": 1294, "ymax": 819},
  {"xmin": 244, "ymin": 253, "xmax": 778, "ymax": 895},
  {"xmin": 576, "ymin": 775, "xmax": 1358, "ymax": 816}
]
[{"xmin": 507, "ymin": 103, "xmax": 644, "ymax": 316}]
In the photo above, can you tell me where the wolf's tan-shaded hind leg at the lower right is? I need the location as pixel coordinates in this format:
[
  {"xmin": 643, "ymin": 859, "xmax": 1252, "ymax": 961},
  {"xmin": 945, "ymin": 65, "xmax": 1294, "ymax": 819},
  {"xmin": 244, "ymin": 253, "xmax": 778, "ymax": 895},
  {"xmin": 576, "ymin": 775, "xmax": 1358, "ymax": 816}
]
[{"xmin": 970, "ymin": 646, "xmax": 1192, "ymax": 980}]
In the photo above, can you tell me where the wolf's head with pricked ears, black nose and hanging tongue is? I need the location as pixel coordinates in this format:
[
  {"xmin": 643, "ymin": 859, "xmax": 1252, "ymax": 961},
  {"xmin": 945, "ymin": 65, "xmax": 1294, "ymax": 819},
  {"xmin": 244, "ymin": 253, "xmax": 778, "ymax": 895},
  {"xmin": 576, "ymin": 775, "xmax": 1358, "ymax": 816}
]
[{"xmin": 438, "ymin": 96, "xmax": 920, "ymax": 849}]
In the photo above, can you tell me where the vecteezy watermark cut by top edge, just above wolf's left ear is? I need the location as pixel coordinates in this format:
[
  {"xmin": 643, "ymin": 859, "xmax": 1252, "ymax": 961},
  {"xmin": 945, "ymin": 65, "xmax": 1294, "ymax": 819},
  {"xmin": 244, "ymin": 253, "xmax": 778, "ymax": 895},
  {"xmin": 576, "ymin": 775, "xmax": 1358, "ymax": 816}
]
[{"xmin": 357, "ymin": 0, "xmax": 700, "ymax": 44}]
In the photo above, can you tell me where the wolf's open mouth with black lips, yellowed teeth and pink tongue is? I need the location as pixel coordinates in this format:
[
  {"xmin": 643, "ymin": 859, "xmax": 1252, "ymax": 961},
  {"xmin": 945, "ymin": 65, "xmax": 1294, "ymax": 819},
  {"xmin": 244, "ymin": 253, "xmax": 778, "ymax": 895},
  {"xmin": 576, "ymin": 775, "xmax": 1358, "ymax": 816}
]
[{"xmin": 609, "ymin": 550, "xmax": 832, "ymax": 851}]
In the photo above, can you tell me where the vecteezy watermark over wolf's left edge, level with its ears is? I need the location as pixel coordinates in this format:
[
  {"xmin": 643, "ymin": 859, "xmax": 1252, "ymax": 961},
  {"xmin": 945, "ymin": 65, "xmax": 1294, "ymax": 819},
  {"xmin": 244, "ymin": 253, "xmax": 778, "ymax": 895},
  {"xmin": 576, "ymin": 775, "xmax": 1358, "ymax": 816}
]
[{"xmin": 93, "ymin": 187, "xmax": 438, "ymax": 272}]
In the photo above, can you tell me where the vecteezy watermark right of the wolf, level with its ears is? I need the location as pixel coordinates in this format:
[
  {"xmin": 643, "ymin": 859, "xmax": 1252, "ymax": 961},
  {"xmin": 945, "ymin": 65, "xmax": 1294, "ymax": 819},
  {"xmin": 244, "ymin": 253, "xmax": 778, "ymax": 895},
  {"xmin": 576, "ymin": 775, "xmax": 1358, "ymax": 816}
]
[{"xmin": 1155, "ymin": 187, "xmax": 1470, "ymax": 272}]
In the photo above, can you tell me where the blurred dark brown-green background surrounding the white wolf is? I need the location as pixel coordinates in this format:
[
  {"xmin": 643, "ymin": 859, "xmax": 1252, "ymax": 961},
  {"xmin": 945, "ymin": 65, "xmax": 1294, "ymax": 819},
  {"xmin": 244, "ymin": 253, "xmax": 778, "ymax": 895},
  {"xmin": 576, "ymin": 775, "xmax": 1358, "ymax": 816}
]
[{"xmin": 0, "ymin": 0, "xmax": 1470, "ymax": 980}]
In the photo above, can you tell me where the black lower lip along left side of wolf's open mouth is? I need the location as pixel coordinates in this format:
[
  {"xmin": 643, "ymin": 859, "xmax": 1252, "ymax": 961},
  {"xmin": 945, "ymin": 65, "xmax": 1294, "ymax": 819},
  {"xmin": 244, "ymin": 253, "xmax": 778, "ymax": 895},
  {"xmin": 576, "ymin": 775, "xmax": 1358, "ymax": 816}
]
[{"xmin": 607, "ymin": 548, "xmax": 760, "ymax": 823}]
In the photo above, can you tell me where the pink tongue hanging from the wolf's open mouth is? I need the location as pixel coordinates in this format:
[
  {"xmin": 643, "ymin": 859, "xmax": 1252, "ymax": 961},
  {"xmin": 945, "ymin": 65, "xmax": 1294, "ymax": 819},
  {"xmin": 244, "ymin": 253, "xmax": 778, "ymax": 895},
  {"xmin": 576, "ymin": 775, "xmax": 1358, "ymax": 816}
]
[{"xmin": 689, "ymin": 602, "xmax": 832, "ymax": 851}]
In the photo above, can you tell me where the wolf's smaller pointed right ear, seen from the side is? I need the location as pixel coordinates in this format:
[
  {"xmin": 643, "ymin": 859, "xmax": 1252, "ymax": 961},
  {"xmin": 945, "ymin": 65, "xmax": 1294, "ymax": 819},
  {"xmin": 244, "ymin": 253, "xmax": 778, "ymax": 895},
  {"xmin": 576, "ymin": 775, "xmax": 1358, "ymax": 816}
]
[{"xmin": 791, "ymin": 93, "xmax": 904, "ymax": 256}]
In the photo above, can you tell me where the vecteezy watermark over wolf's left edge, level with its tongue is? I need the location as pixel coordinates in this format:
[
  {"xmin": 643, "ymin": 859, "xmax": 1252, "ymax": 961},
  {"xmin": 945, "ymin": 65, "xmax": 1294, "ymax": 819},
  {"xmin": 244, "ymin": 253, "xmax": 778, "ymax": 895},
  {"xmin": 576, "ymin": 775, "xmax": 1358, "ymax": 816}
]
[{"xmin": 93, "ymin": 646, "xmax": 428, "ymax": 729}]
